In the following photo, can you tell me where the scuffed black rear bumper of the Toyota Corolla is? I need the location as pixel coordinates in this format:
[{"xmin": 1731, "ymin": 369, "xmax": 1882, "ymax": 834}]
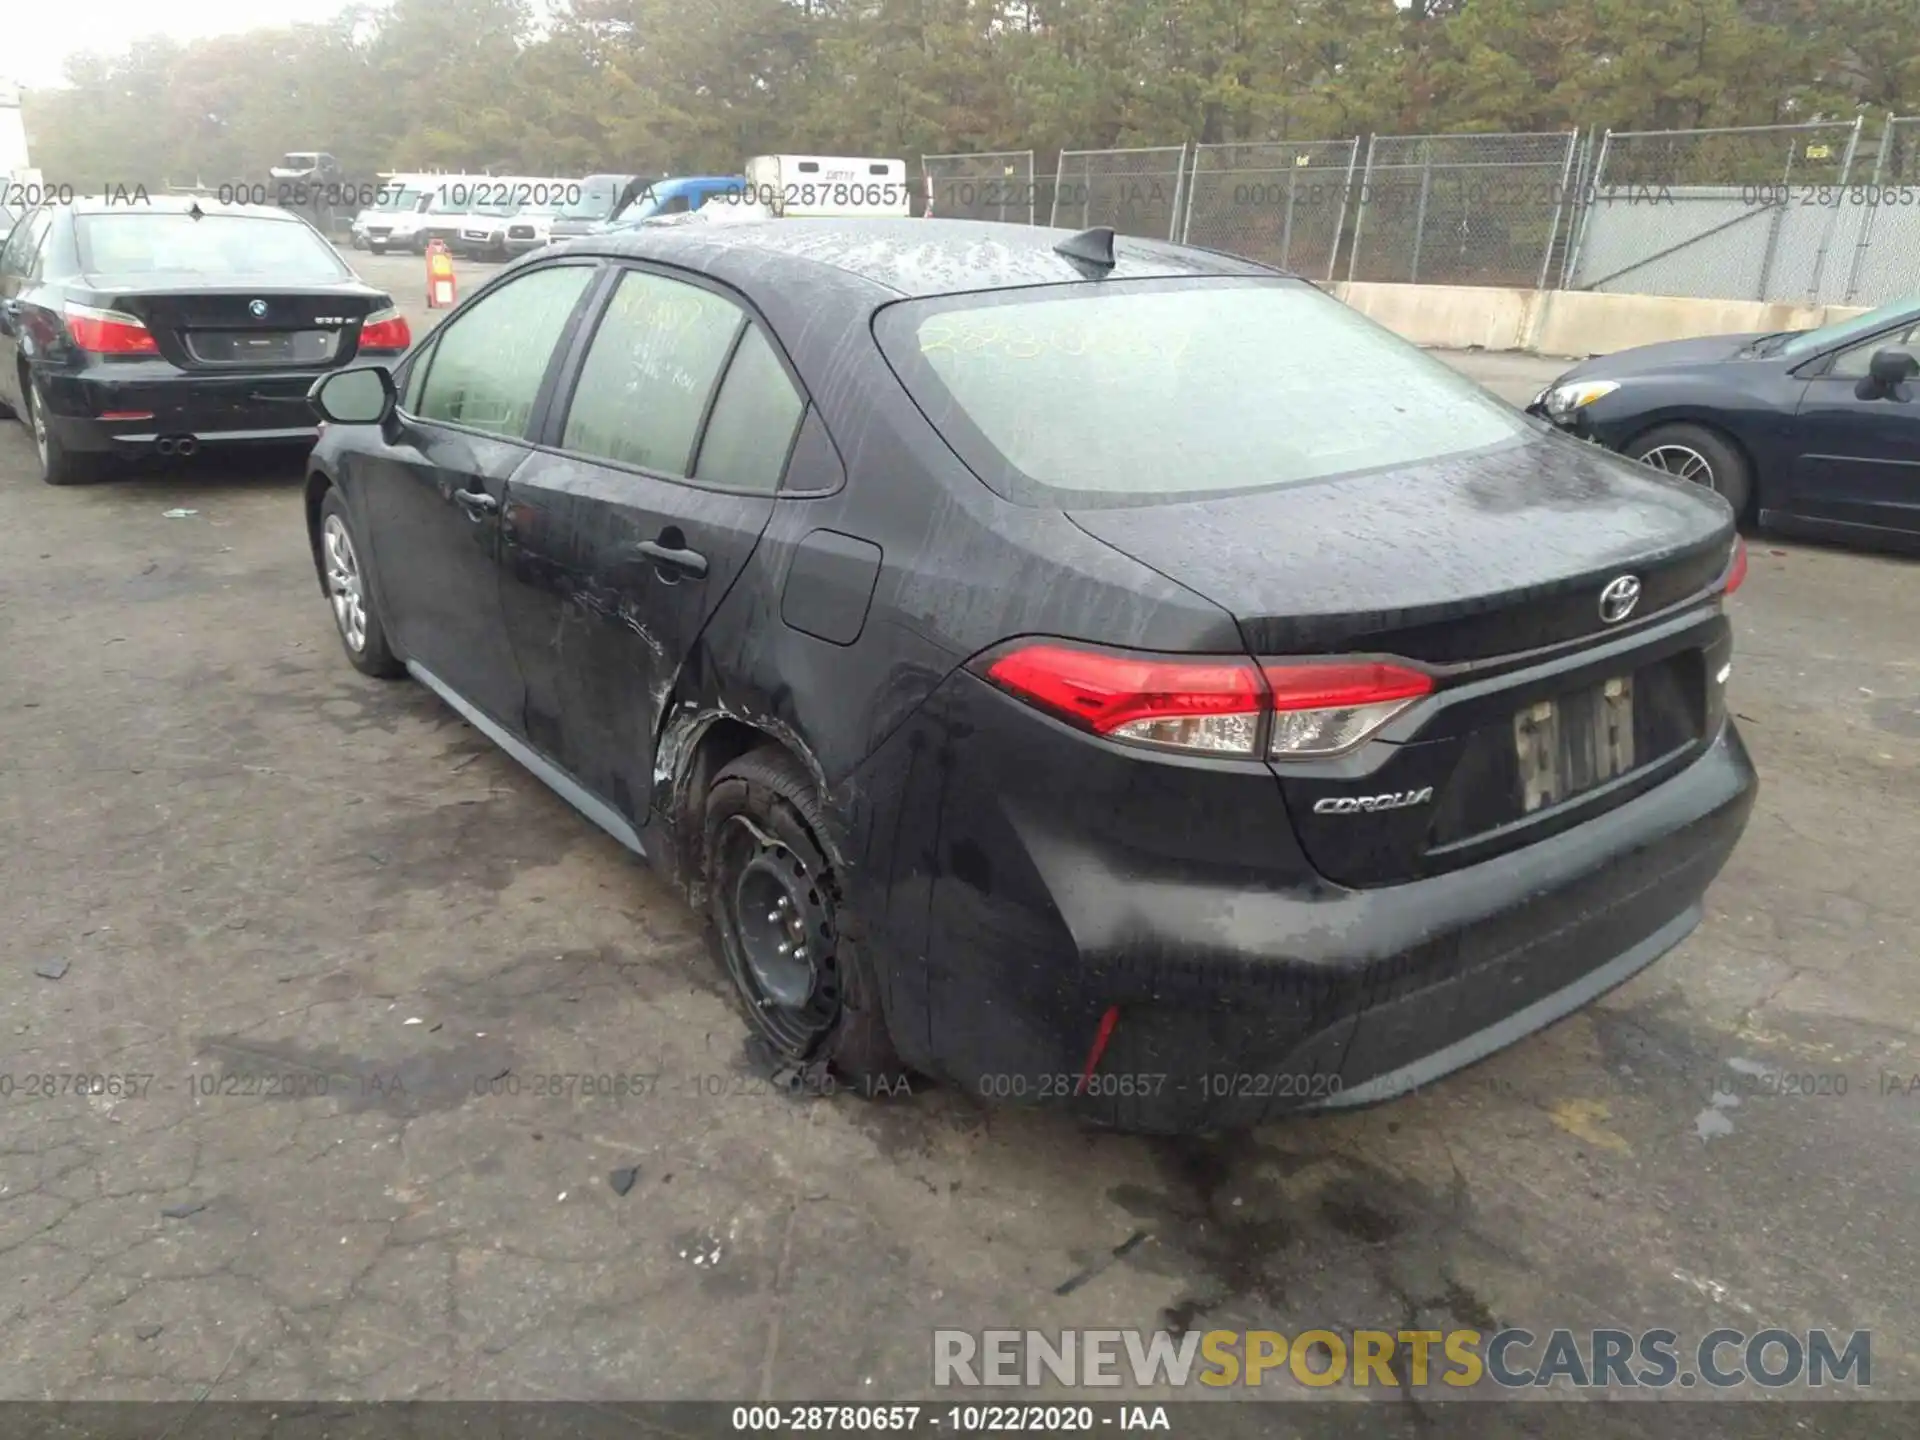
[{"xmin": 862, "ymin": 678, "xmax": 1757, "ymax": 1133}]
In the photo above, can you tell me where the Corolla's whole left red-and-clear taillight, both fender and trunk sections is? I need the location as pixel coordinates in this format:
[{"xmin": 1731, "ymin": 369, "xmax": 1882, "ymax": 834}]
[{"xmin": 985, "ymin": 643, "xmax": 1432, "ymax": 760}]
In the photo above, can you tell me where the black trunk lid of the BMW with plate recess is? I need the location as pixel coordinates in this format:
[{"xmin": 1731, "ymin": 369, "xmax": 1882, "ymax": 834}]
[{"xmin": 86, "ymin": 275, "xmax": 394, "ymax": 372}]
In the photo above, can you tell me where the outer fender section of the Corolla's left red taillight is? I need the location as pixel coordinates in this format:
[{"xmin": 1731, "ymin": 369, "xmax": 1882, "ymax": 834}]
[{"xmin": 987, "ymin": 645, "xmax": 1267, "ymax": 755}]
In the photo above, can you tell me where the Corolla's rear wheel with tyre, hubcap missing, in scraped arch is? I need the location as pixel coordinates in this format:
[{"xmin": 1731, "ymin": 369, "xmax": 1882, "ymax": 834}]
[{"xmin": 701, "ymin": 747, "xmax": 906, "ymax": 1094}]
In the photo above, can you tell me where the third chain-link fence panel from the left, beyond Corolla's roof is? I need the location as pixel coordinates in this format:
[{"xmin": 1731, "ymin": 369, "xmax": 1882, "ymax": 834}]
[{"xmin": 1181, "ymin": 136, "xmax": 1359, "ymax": 280}]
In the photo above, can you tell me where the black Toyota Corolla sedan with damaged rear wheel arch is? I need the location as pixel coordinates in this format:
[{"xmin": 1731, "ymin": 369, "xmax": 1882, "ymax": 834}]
[{"xmin": 307, "ymin": 221, "xmax": 1755, "ymax": 1131}]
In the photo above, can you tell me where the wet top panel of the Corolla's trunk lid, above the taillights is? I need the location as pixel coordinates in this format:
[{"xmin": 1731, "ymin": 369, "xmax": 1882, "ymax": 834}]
[{"xmin": 1069, "ymin": 434, "xmax": 1734, "ymax": 664}]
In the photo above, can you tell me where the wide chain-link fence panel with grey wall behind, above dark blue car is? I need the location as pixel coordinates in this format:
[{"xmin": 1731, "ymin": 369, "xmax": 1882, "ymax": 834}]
[{"xmin": 1569, "ymin": 121, "xmax": 1860, "ymax": 301}]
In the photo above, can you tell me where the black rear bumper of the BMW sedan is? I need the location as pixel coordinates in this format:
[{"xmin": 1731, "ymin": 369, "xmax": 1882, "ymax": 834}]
[{"xmin": 36, "ymin": 355, "xmax": 351, "ymax": 455}]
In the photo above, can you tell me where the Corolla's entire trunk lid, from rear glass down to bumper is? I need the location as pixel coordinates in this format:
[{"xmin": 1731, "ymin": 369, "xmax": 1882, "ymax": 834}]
[{"xmin": 1071, "ymin": 426, "xmax": 1734, "ymax": 887}]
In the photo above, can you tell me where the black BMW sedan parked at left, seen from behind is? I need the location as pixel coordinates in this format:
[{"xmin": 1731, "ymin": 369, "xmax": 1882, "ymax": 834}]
[{"xmin": 0, "ymin": 196, "xmax": 411, "ymax": 486}]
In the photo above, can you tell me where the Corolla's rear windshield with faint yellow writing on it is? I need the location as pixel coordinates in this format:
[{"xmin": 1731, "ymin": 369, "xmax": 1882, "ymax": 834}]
[{"xmin": 876, "ymin": 278, "xmax": 1528, "ymax": 505}]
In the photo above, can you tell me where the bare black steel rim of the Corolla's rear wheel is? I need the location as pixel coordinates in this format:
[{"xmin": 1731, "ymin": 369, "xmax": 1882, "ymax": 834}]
[{"xmin": 714, "ymin": 814, "xmax": 841, "ymax": 1060}]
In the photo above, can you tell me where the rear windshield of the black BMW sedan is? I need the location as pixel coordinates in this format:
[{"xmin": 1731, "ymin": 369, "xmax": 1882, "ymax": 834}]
[{"xmin": 75, "ymin": 209, "xmax": 351, "ymax": 282}]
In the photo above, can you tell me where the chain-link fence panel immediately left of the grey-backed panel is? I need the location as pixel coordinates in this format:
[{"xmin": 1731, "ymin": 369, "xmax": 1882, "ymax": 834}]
[{"xmin": 1346, "ymin": 131, "xmax": 1580, "ymax": 286}]
